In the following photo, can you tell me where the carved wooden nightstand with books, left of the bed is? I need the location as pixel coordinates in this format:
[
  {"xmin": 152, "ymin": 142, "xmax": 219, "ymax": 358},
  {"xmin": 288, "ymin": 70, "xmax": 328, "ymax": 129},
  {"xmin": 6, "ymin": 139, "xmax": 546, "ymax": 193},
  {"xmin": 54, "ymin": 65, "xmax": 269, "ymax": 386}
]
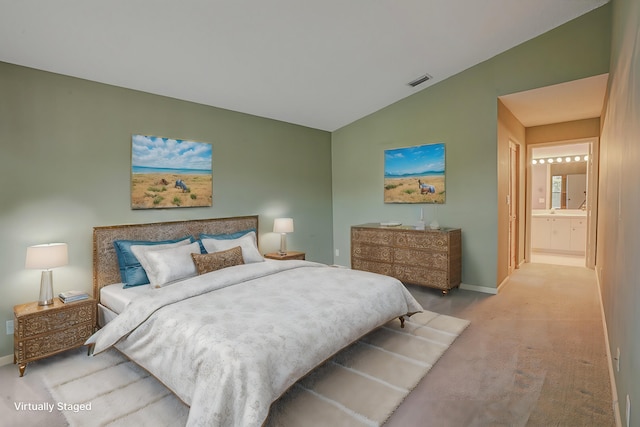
[{"xmin": 13, "ymin": 297, "xmax": 96, "ymax": 376}]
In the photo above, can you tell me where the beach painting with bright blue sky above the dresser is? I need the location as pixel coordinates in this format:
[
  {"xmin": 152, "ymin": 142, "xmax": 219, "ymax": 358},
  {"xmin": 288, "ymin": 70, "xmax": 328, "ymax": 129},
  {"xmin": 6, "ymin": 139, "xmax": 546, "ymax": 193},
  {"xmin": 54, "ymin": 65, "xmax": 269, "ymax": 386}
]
[{"xmin": 384, "ymin": 143, "xmax": 446, "ymax": 204}]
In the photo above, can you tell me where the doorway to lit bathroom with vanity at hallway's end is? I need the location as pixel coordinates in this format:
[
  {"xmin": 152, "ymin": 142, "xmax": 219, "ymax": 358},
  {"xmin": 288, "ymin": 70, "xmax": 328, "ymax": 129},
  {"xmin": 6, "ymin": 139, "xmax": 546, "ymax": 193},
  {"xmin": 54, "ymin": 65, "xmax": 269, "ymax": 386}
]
[{"xmin": 528, "ymin": 138, "xmax": 597, "ymax": 267}]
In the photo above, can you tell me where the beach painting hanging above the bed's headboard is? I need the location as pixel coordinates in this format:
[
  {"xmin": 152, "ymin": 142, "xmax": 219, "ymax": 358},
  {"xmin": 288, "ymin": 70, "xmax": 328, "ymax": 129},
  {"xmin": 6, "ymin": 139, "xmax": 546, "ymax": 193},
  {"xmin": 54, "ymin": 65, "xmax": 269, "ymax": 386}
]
[{"xmin": 131, "ymin": 135, "xmax": 213, "ymax": 209}]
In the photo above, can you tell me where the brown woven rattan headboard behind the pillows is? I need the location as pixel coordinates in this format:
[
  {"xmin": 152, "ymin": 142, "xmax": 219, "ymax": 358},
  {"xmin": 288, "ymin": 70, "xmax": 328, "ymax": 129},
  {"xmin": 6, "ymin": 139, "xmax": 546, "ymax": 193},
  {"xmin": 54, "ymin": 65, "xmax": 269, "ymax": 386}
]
[{"xmin": 93, "ymin": 215, "xmax": 258, "ymax": 301}]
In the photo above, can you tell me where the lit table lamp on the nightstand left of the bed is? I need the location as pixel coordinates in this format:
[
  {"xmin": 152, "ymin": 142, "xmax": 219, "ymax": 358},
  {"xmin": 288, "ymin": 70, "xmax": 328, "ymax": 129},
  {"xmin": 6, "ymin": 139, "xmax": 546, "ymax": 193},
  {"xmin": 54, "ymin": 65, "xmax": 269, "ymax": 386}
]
[{"xmin": 24, "ymin": 243, "xmax": 69, "ymax": 305}]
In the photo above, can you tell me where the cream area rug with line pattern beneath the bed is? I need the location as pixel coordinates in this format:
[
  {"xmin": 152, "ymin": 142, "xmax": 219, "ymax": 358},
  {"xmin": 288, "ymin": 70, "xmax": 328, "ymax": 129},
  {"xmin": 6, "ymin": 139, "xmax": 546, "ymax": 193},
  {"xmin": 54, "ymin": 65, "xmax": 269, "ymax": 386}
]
[{"xmin": 45, "ymin": 311, "xmax": 469, "ymax": 427}]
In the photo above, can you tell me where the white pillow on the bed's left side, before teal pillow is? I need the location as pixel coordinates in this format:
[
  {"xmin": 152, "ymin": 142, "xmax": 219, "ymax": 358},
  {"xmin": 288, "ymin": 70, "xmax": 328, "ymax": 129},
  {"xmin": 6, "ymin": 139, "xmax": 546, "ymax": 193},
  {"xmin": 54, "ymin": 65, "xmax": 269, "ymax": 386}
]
[{"xmin": 140, "ymin": 242, "xmax": 200, "ymax": 288}]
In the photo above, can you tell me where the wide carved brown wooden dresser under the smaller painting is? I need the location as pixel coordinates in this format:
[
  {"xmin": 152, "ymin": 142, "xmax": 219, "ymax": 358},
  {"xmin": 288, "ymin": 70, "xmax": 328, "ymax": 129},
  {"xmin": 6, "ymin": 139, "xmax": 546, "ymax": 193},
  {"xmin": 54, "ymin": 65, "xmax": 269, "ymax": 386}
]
[{"xmin": 351, "ymin": 223, "xmax": 462, "ymax": 294}]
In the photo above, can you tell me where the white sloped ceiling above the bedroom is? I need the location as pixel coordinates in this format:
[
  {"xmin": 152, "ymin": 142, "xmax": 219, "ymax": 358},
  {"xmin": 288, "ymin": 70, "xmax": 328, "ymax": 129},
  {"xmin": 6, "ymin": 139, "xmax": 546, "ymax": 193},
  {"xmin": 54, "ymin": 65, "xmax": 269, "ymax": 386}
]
[{"xmin": 0, "ymin": 0, "xmax": 608, "ymax": 131}]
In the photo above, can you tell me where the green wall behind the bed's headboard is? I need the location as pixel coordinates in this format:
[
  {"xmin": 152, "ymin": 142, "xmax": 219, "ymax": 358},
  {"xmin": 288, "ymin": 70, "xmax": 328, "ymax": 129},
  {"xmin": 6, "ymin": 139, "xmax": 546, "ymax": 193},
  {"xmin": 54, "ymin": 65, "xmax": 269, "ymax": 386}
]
[{"xmin": 0, "ymin": 63, "xmax": 332, "ymax": 356}]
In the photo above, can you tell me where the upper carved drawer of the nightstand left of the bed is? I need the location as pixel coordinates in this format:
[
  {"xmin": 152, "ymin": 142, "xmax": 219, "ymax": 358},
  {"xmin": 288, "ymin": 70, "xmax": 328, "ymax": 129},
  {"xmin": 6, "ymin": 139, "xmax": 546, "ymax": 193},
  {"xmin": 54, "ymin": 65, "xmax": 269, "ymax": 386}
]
[{"xmin": 15, "ymin": 302, "xmax": 94, "ymax": 339}]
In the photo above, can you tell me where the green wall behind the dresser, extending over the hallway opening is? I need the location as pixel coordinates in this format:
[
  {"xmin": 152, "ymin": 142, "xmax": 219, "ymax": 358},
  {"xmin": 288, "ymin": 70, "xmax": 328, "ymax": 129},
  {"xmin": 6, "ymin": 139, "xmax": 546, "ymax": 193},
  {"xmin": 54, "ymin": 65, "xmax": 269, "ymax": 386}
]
[{"xmin": 332, "ymin": 5, "xmax": 611, "ymax": 292}]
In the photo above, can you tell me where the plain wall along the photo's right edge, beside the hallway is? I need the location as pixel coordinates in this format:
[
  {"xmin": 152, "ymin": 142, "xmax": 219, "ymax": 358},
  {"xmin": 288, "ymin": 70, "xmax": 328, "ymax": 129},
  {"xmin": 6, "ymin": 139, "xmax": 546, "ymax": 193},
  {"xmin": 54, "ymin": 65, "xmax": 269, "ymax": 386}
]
[{"xmin": 596, "ymin": 0, "xmax": 640, "ymax": 426}]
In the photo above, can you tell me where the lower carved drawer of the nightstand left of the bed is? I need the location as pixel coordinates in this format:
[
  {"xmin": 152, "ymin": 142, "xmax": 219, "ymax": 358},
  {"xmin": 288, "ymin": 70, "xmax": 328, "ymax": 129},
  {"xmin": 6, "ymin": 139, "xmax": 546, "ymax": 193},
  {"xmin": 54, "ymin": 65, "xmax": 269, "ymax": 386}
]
[{"xmin": 15, "ymin": 321, "xmax": 93, "ymax": 362}]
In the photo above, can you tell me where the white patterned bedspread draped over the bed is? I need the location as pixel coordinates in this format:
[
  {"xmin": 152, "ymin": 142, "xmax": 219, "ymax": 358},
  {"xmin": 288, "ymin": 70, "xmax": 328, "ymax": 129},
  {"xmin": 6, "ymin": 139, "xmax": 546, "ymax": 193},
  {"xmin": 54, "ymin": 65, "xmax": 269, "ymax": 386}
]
[{"xmin": 88, "ymin": 261, "xmax": 422, "ymax": 427}]
